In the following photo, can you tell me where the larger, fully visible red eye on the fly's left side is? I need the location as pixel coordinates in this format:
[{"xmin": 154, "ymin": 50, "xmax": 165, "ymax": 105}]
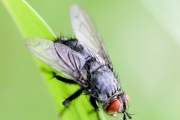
[{"xmin": 106, "ymin": 100, "xmax": 121, "ymax": 114}]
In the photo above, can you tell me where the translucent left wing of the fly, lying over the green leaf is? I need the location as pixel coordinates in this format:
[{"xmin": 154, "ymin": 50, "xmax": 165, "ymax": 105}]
[{"xmin": 26, "ymin": 38, "xmax": 85, "ymax": 80}]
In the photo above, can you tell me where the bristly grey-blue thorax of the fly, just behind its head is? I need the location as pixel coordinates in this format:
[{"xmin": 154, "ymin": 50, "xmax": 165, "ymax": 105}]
[{"xmin": 85, "ymin": 61, "xmax": 120, "ymax": 102}]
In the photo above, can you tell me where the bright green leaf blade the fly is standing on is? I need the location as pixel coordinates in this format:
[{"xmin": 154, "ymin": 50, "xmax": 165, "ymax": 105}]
[{"xmin": 3, "ymin": 0, "xmax": 104, "ymax": 120}]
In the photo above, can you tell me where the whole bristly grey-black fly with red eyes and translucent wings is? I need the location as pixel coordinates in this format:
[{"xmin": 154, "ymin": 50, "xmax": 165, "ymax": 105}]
[{"xmin": 26, "ymin": 5, "xmax": 131, "ymax": 120}]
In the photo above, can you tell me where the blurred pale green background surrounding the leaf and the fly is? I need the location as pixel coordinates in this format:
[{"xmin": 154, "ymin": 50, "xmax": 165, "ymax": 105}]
[{"xmin": 0, "ymin": 0, "xmax": 180, "ymax": 120}]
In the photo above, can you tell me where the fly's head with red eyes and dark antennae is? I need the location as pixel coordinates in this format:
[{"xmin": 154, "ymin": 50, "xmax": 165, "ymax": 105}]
[{"xmin": 103, "ymin": 93, "xmax": 132, "ymax": 120}]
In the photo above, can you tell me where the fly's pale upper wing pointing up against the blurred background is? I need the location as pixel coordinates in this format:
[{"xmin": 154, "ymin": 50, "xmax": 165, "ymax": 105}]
[{"xmin": 70, "ymin": 5, "xmax": 113, "ymax": 70}]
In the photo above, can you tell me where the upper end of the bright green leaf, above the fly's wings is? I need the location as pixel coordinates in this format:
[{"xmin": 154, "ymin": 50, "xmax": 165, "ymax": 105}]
[{"xmin": 3, "ymin": 0, "xmax": 56, "ymax": 39}]
